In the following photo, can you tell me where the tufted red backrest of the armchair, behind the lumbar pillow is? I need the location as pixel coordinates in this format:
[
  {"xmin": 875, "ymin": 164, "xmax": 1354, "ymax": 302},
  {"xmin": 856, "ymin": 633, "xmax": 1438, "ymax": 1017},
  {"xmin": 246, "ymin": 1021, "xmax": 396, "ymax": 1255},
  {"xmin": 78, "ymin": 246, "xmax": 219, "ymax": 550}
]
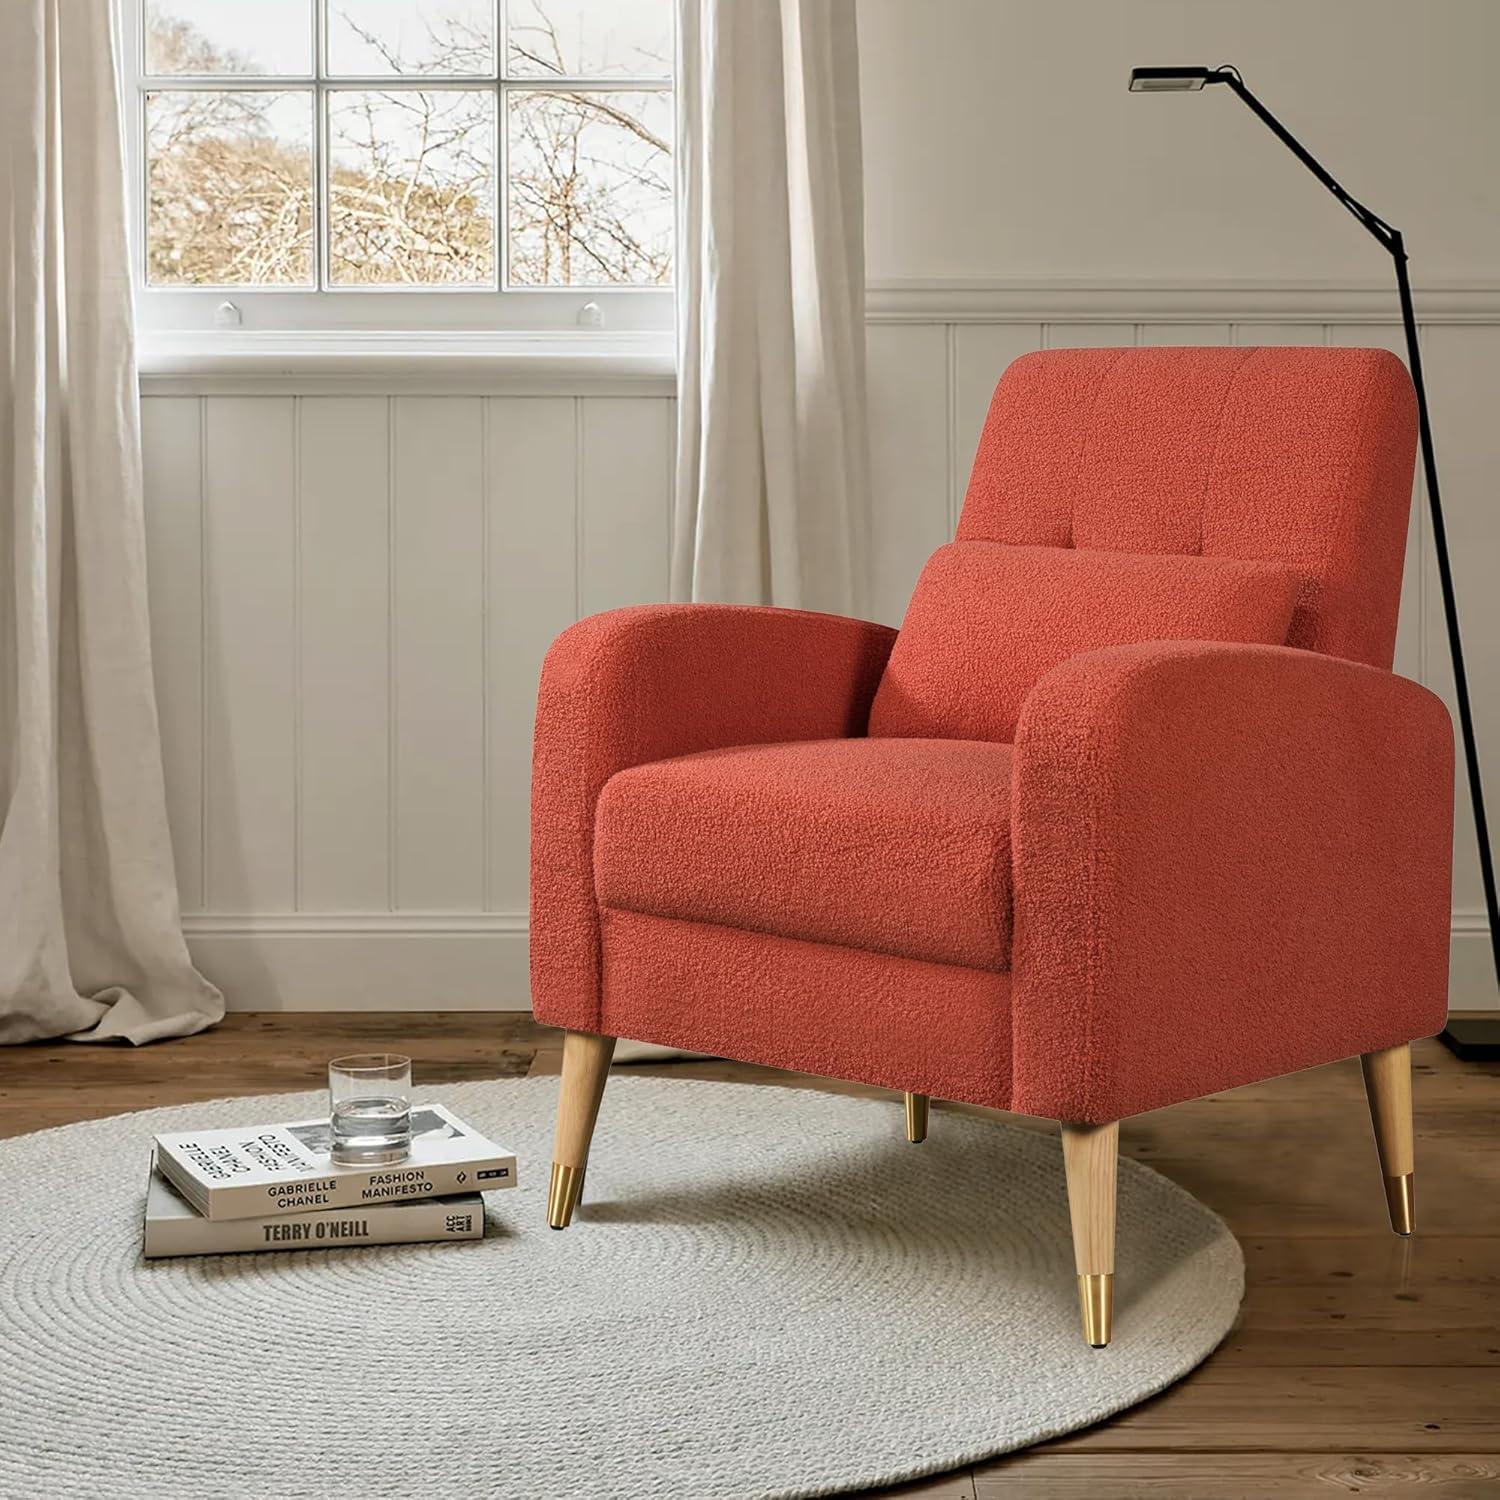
[{"xmin": 959, "ymin": 348, "xmax": 1416, "ymax": 668}]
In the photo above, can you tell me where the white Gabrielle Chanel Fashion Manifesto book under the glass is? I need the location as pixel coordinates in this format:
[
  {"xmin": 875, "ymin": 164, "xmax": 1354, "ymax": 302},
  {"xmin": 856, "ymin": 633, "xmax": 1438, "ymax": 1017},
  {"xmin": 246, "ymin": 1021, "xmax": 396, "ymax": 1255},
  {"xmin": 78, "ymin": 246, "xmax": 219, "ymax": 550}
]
[{"xmin": 156, "ymin": 1104, "xmax": 516, "ymax": 1220}]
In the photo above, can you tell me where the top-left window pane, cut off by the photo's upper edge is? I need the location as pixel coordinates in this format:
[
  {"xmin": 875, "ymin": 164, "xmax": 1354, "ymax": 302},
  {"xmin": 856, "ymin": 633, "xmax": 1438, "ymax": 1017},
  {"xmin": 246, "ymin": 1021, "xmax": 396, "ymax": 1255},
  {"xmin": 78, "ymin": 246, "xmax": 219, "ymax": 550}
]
[{"xmin": 146, "ymin": 0, "xmax": 312, "ymax": 75}]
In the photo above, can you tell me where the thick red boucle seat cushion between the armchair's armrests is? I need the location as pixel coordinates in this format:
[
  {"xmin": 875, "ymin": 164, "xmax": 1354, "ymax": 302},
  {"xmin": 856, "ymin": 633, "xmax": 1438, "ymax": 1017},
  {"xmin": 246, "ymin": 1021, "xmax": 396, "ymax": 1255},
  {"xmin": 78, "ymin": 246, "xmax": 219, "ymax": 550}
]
[{"xmin": 594, "ymin": 738, "xmax": 1011, "ymax": 972}]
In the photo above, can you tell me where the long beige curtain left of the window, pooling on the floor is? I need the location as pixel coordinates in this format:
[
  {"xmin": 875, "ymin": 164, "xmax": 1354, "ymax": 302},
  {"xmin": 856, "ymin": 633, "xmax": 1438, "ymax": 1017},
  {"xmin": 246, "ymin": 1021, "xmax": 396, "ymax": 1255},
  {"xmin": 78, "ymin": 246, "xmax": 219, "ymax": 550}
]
[{"xmin": 0, "ymin": 0, "xmax": 224, "ymax": 1043}]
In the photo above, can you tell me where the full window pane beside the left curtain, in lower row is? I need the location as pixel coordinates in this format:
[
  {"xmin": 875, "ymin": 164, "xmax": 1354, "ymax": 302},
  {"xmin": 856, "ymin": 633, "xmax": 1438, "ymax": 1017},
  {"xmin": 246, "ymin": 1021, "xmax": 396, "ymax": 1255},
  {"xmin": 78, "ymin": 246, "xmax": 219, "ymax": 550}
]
[{"xmin": 146, "ymin": 89, "xmax": 314, "ymax": 287}]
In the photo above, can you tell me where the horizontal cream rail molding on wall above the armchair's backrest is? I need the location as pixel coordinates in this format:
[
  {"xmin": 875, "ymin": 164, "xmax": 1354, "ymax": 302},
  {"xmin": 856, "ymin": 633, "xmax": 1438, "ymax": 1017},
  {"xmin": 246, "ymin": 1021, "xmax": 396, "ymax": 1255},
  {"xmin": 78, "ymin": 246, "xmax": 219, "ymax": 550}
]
[{"xmin": 866, "ymin": 278, "xmax": 1500, "ymax": 326}]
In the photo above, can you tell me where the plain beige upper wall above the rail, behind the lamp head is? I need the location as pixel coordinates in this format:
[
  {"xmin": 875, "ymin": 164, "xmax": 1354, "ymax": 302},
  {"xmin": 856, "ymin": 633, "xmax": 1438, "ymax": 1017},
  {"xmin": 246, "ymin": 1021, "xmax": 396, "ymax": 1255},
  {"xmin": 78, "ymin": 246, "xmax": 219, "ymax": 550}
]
[{"xmin": 860, "ymin": 0, "xmax": 1500, "ymax": 285}]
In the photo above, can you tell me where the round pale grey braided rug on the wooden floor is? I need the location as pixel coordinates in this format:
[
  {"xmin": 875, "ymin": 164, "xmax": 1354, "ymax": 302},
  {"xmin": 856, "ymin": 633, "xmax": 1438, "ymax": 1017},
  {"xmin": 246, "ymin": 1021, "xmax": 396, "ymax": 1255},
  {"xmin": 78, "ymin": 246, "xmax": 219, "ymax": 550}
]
[{"xmin": 0, "ymin": 1074, "xmax": 1244, "ymax": 1500}]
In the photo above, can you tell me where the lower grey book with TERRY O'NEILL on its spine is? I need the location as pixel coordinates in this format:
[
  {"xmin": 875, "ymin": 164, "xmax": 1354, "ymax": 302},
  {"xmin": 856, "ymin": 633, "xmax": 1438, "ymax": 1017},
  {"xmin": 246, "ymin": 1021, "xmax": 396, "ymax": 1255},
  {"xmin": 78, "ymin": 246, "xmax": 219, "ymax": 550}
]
[{"xmin": 143, "ymin": 1170, "xmax": 485, "ymax": 1260}]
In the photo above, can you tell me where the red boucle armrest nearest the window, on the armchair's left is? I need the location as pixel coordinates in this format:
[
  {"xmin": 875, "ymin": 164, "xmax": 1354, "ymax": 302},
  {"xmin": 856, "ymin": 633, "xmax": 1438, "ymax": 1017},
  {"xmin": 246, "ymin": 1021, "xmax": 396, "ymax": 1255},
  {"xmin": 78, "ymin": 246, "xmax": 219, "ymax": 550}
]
[{"xmin": 531, "ymin": 605, "xmax": 896, "ymax": 1031}]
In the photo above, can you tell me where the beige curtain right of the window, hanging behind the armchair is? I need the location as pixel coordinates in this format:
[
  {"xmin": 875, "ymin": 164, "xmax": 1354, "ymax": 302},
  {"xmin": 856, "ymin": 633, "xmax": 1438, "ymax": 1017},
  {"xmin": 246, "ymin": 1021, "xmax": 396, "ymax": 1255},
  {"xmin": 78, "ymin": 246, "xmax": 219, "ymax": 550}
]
[{"xmin": 672, "ymin": 0, "xmax": 869, "ymax": 614}]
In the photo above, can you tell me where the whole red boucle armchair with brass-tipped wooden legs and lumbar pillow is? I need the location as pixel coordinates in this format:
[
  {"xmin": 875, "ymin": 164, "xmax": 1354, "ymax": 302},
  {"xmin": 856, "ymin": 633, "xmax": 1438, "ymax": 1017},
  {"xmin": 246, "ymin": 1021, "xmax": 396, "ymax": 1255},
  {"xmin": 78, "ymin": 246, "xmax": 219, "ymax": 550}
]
[{"xmin": 531, "ymin": 348, "xmax": 1454, "ymax": 1344}]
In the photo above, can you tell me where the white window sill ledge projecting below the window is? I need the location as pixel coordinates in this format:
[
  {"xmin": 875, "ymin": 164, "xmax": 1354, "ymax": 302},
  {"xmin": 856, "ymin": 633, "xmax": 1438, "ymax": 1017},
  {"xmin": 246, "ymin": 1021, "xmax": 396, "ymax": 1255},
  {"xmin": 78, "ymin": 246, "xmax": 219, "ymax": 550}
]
[{"xmin": 137, "ymin": 329, "xmax": 677, "ymax": 396}]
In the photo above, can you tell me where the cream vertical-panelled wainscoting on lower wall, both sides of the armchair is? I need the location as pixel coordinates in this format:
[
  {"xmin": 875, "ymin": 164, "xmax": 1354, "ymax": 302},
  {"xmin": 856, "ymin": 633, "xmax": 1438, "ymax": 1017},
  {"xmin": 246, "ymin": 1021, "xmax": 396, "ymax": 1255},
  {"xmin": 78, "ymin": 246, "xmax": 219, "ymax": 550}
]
[{"xmin": 143, "ymin": 285, "xmax": 1500, "ymax": 1010}]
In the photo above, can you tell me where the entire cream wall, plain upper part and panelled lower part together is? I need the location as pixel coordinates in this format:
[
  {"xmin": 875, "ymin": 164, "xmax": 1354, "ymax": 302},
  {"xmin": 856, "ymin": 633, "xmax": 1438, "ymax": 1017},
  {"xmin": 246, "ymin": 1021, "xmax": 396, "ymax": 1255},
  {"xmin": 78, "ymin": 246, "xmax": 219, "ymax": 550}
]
[{"xmin": 144, "ymin": 0, "xmax": 1500, "ymax": 1010}]
